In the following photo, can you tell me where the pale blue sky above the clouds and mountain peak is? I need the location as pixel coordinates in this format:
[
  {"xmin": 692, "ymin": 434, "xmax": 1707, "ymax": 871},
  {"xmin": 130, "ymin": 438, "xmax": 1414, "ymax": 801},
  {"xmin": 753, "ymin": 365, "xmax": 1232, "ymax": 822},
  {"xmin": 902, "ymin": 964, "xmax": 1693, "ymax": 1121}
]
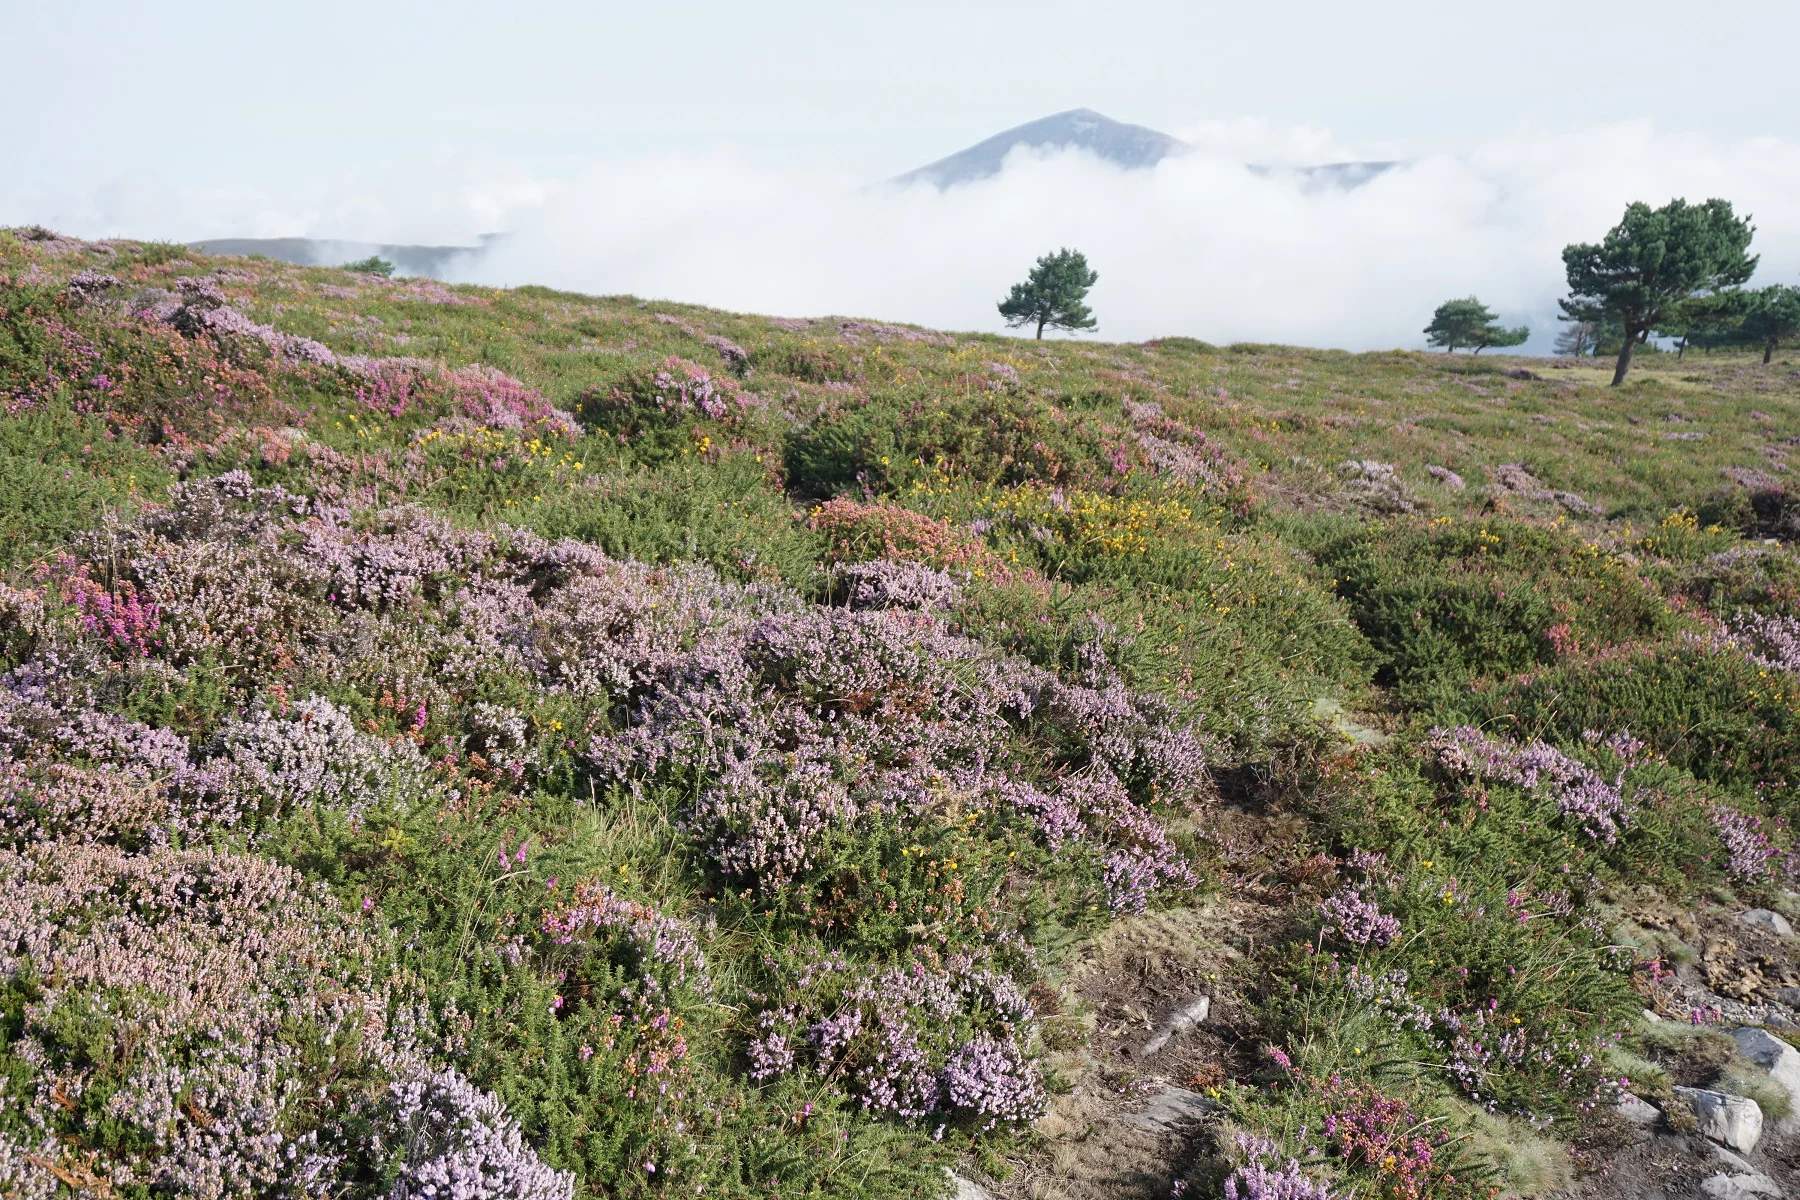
[{"xmin": 14, "ymin": 0, "xmax": 1800, "ymax": 187}]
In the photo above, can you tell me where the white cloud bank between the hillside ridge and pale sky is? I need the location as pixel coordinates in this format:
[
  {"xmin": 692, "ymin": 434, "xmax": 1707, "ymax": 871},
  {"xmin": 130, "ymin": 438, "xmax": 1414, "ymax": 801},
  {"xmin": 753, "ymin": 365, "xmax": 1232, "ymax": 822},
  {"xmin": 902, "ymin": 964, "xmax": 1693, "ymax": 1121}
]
[{"xmin": 14, "ymin": 121, "xmax": 1800, "ymax": 351}]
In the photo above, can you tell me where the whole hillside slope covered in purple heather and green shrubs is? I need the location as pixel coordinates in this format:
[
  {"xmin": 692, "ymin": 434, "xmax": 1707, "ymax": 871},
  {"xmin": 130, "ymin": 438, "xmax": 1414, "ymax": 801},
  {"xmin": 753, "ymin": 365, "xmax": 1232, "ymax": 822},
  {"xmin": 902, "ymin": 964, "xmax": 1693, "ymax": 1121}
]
[{"xmin": 0, "ymin": 230, "xmax": 1800, "ymax": 1198}]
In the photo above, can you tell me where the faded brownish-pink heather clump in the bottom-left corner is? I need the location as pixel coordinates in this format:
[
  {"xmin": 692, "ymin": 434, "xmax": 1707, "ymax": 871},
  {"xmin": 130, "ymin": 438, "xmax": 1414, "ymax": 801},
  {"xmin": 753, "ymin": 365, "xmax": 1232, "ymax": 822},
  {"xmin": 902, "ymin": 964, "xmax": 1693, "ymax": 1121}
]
[{"xmin": 0, "ymin": 846, "xmax": 385, "ymax": 1196}]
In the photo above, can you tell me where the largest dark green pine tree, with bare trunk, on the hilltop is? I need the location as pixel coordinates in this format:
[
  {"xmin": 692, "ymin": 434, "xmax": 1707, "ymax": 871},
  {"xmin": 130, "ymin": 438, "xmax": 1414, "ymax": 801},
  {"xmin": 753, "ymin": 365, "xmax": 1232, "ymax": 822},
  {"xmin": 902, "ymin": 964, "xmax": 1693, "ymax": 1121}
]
[{"xmin": 1562, "ymin": 200, "xmax": 1757, "ymax": 387}]
